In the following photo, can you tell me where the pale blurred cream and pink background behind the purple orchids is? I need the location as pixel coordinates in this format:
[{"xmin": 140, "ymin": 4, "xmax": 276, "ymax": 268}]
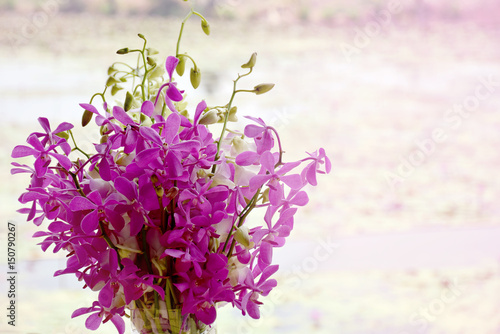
[{"xmin": 0, "ymin": 0, "xmax": 500, "ymax": 334}]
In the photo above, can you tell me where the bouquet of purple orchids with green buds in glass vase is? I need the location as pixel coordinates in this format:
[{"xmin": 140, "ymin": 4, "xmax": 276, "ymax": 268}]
[{"xmin": 12, "ymin": 5, "xmax": 331, "ymax": 334}]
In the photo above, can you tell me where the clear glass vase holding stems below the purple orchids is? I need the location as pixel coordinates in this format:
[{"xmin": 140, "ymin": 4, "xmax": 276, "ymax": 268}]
[{"xmin": 131, "ymin": 302, "xmax": 217, "ymax": 334}]
